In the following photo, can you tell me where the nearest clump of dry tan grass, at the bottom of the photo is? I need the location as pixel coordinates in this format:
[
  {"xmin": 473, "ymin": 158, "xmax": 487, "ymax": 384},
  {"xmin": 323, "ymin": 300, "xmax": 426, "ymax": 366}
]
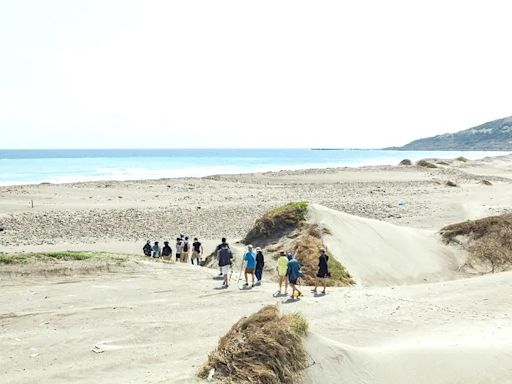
[{"xmin": 199, "ymin": 305, "xmax": 308, "ymax": 384}]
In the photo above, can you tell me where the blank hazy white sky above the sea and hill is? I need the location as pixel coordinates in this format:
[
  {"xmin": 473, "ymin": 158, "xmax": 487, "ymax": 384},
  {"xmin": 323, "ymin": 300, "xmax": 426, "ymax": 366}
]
[{"xmin": 0, "ymin": 0, "xmax": 512, "ymax": 148}]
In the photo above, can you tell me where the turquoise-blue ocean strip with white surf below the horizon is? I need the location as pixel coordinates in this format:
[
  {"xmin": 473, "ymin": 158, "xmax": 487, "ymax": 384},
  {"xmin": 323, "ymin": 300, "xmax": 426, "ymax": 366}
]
[{"xmin": 0, "ymin": 149, "xmax": 506, "ymax": 185}]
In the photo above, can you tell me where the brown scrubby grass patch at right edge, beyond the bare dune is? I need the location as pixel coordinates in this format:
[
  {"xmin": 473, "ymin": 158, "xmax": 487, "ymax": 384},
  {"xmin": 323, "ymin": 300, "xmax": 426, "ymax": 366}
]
[{"xmin": 441, "ymin": 213, "xmax": 512, "ymax": 273}]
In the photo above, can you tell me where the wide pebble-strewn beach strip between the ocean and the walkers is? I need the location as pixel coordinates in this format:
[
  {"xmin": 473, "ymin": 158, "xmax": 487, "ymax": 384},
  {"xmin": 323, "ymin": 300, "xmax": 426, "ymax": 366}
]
[{"xmin": 0, "ymin": 155, "xmax": 512, "ymax": 252}]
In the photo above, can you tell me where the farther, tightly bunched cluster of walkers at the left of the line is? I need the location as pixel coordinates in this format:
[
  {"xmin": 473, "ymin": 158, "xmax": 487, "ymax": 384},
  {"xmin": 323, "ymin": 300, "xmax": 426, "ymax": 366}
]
[{"xmin": 142, "ymin": 235, "xmax": 203, "ymax": 265}]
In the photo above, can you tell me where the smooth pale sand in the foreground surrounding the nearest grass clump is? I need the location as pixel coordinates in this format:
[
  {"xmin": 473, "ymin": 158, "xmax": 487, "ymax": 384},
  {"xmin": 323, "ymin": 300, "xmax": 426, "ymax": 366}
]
[{"xmin": 0, "ymin": 255, "xmax": 512, "ymax": 384}]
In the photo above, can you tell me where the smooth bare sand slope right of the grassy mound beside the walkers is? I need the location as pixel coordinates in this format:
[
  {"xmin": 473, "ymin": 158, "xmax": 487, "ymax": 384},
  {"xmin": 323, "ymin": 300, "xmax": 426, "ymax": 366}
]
[{"xmin": 309, "ymin": 205, "xmax": 464, "ymax": 286}]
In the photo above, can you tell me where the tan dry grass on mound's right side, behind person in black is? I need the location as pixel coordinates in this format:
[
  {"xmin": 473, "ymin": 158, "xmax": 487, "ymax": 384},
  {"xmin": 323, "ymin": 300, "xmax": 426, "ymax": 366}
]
[{"xmin": 290, "ymin": 225, "xmax": 354, "ymax": 287}]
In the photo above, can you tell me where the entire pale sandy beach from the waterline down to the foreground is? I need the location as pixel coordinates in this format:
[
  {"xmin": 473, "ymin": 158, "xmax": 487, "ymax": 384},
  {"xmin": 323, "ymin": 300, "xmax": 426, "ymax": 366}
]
[{"xmin": 0, "ymin": 155, "xmax": 512, "ymax": 384}]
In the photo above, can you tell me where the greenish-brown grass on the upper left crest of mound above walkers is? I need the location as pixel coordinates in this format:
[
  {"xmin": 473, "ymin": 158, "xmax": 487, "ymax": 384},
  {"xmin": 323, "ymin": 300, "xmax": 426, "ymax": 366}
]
[{"xmin": 243, "ymin": 201, "xmax": 308, "ymax": 246}]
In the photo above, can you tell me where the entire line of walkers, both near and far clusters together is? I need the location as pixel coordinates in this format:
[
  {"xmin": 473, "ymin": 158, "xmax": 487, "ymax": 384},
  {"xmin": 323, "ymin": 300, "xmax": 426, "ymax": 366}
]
[{"xmin": 143, "ymin": 235, "xmax": 331, "ymax": 298}]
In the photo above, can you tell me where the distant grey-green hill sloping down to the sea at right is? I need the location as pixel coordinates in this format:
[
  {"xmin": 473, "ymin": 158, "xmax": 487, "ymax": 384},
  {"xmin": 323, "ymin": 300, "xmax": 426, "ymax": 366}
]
[{"xmin": 386, "ymin": 116, "xmax": 512, "ymax": 151}]
